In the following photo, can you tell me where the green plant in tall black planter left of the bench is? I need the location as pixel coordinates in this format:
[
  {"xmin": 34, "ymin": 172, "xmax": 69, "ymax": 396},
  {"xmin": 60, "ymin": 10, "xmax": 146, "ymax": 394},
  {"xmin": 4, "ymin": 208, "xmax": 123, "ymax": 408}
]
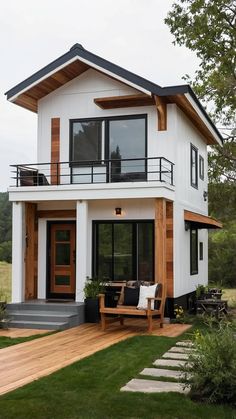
[{"xmin": 84, "ymin": 278, "xmax": 105, "ymax": 323}]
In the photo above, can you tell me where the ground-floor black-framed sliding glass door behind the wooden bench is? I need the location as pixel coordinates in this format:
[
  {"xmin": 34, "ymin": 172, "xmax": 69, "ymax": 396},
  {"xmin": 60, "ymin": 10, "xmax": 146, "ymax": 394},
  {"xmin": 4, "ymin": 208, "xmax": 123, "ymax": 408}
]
[{"xmin": 93, "ymin": 221, "xmax": 154, "ymax": 281}]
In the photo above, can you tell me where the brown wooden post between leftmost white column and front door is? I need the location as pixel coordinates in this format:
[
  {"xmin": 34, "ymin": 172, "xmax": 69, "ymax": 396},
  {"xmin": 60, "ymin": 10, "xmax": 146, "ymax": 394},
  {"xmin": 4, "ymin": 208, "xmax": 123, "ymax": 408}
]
[{"xmin": 25, "ymin": 203, "xmax": 38, "ymax": 300}]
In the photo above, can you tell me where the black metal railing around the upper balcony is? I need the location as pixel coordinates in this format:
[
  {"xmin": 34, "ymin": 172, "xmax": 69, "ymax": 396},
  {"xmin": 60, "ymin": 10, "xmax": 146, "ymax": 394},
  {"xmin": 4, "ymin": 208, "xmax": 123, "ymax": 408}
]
[{"xmin": 11, "ymin": 157, "xmax": 174, "ymax": 187}]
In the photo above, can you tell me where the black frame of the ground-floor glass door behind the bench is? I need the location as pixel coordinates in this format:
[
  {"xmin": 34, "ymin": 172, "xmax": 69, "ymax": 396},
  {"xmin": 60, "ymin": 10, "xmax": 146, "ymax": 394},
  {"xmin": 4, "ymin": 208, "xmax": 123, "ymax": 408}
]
[{"xmin": 92, "ymin": 219, "xmax": 155, "ymax": 282}]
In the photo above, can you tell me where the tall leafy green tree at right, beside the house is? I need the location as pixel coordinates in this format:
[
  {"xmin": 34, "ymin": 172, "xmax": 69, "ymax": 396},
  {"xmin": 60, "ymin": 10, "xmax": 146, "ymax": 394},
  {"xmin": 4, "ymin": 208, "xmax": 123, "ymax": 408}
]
[{"xmin": 165, "ymin": 0, "xmax": 236, "ymax": 286}]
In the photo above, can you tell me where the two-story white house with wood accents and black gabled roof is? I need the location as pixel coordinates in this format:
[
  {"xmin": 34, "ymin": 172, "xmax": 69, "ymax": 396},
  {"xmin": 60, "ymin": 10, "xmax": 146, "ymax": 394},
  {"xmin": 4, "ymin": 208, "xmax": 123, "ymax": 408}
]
[{"xmin": 6, "ymin": 44, "xmax": 222, "ymax": 332}]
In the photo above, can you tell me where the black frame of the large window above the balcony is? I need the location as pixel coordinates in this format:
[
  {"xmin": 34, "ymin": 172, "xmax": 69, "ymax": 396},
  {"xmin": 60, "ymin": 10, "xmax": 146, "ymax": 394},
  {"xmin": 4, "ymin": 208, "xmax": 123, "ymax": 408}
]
[{"xmin": 69, "ymin": 114, "xmax": 148, "ymax": 170}]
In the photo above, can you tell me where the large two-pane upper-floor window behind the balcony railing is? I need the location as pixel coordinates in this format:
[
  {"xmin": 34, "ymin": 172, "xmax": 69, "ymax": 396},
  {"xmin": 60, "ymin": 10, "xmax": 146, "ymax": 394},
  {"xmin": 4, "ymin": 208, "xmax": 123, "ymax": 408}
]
[{"xmin": 70, "ymin": 115, "xmax": 147, "ymax": 182}]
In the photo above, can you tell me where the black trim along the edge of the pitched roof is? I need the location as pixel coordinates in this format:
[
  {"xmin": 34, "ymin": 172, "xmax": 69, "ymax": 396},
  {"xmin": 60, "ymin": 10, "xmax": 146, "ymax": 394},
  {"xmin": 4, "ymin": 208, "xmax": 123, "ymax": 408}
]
[{"xmin": 5, "ymin": 44, "xmax": 223, "ymax": 144}]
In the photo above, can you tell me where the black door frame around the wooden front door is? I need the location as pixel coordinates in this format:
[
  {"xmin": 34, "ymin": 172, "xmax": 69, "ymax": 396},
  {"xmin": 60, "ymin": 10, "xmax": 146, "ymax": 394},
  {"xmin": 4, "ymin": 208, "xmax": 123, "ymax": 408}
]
[{"xmin": 46, "ymin": 219, "xmax": 76, "ymax": 300}]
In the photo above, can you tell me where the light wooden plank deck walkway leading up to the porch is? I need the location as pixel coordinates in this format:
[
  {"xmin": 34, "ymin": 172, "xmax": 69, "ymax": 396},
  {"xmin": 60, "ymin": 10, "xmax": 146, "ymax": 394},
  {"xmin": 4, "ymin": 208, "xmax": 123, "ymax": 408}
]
[{"xmin": 0, "ymin": 319, "xmax": 190, "ymax": 394}]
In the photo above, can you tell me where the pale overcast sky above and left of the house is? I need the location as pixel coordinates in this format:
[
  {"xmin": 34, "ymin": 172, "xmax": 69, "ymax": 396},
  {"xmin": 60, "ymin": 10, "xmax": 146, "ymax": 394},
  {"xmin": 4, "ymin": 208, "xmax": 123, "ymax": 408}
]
[{"xmin": 0, "ymin": 0, "xmax": 198, "ymax": 191}]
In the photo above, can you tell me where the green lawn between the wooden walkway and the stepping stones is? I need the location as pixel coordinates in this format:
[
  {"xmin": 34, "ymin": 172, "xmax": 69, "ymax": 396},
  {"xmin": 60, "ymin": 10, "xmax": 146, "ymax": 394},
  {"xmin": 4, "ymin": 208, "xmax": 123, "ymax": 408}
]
[{"xmin": 0, "ymin": 336, "xmax": 236, "ymax": 419}]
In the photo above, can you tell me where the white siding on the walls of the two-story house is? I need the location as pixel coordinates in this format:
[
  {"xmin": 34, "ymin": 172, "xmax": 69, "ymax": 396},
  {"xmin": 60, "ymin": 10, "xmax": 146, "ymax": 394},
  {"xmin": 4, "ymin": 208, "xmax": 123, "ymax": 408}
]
[{"xmin": 10, "ymin": 69, "xmax": 210, "ymax": 298}]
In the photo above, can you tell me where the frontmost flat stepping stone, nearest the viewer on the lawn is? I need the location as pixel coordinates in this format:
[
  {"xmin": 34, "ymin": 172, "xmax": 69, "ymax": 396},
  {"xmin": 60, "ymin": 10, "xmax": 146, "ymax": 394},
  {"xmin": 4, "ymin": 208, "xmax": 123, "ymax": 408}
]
[{"xmin": 121, "ymin": 378, "xmax": 189, "ymax": 394}]
